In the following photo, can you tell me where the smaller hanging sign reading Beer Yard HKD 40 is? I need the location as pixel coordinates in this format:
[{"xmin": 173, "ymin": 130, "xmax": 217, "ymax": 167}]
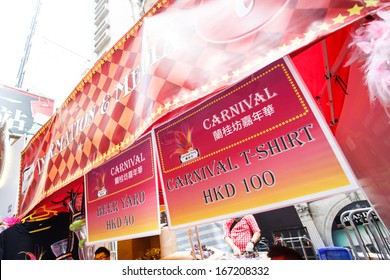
[{"xmin": 85, "ymin": 133, "xmax": 160, "ymax": 243}]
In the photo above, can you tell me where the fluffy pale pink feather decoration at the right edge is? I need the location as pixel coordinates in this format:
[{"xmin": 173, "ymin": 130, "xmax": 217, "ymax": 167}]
[{"xmin": 346, "ymin": 10, "xmax": 390, "ymax": 107}]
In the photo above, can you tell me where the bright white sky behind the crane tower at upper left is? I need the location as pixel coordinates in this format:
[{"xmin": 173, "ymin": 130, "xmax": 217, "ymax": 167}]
[{"xmin": 0, "ymin": 0, "xmax": 96, "ymax": 107}]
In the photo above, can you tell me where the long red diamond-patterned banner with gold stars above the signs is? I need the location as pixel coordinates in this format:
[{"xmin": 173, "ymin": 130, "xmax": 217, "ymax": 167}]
[{"xmin": 19, "ymin": 0, "xmax": 388, "ymax": 217}]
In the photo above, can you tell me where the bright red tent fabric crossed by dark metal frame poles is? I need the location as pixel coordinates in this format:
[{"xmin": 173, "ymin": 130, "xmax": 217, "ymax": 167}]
[{"xmin": 293, "ymin": 25, "xmax": 354, "ymax": 133}]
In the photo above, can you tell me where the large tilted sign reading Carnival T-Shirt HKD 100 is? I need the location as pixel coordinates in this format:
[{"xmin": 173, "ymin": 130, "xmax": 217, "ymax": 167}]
[{"xmin": 154, "ymin": 59, "xmax": 357, "ymax": 228}]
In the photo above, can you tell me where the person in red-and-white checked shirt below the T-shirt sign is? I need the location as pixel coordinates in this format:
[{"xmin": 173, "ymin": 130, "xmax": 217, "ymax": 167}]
[{"xmin": 223, "ymin": 215, "xmax": 261, "ymax": 256}]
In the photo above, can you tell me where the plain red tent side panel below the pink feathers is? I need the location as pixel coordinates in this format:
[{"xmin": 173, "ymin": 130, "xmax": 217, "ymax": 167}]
[{"xmin": 335, "ymin": 63, "xmax": 390, "ymax": 232}]
